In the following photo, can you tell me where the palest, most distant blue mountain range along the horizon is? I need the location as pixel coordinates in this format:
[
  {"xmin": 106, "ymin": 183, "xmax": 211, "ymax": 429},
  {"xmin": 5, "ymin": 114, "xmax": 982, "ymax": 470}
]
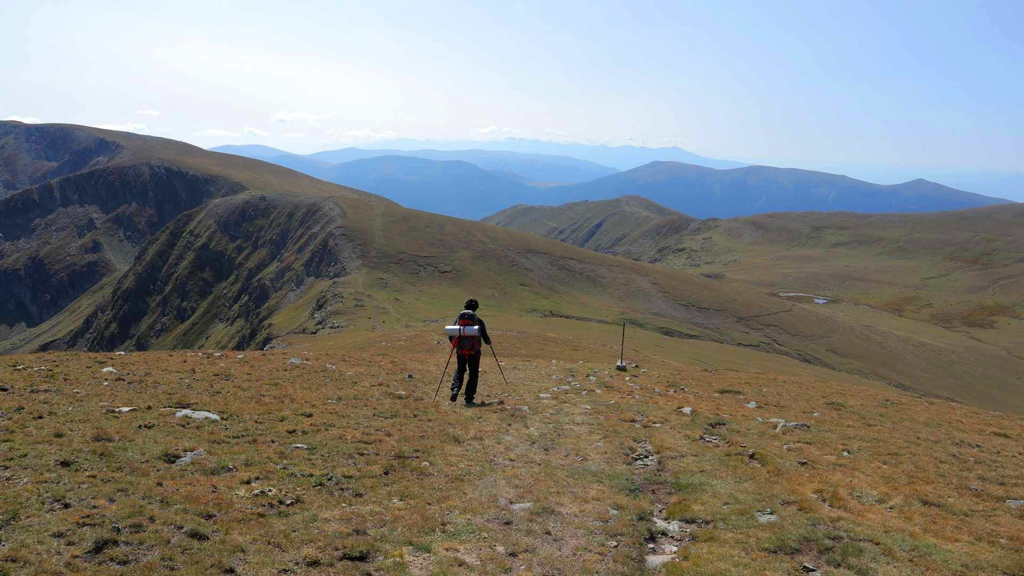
[{"xmin": 348, "ymin": 138, "xmax": 748, "ymax": 170}]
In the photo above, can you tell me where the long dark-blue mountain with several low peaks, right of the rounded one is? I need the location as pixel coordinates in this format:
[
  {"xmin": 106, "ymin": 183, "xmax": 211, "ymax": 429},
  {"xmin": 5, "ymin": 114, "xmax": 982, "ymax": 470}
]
[{"xmin": 550, "ymin": 162, "xmax": 1011, "ymax": 218}]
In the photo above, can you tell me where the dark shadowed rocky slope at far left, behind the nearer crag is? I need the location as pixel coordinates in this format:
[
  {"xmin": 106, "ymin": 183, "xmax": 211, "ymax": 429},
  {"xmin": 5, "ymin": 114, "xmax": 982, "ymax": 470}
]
[{"xmin": 0, "ymin": 122, "xmax": 241, "ymax": 332}]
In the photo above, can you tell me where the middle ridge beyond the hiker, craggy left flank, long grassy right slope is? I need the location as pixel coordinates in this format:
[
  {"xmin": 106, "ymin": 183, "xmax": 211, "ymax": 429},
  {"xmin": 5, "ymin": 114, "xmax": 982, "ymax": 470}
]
[{"xmin": 4, "ymin": 123, "xmax": 1024, "ymax": 410}]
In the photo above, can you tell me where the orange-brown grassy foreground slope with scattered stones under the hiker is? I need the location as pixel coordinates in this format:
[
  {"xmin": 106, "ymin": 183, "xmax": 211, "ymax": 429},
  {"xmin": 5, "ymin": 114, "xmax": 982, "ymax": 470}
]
[{"xmin": 0, "ymin": 323, "xmax": 1024, "ymax": 575}]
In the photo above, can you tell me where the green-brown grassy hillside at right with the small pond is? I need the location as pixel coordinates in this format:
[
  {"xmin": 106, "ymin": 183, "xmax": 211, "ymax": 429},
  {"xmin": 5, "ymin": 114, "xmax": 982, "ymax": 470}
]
[{"xmin": 487, "ymin": 201, "xmax": 1024, "ymax": 411}]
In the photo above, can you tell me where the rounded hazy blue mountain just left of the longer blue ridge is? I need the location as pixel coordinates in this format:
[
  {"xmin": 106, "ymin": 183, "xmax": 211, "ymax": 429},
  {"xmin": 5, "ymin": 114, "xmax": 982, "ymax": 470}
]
[{"xmin": 321, "ymin": 156, "xmax": 549, "ymax": 219}]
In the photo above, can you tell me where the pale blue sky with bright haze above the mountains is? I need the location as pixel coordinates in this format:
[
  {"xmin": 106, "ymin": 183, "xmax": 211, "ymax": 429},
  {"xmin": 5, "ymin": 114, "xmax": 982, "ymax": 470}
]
[{"xmin": 0, "ymin": 0, "xmax": 1024, "ymax": 177}]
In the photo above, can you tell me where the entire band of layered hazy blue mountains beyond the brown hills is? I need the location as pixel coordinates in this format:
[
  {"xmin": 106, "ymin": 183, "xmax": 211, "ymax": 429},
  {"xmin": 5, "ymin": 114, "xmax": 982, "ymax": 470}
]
[{"xmin": 214, "ymin": 144, "xmax": 1009, "ymax": 219}]
